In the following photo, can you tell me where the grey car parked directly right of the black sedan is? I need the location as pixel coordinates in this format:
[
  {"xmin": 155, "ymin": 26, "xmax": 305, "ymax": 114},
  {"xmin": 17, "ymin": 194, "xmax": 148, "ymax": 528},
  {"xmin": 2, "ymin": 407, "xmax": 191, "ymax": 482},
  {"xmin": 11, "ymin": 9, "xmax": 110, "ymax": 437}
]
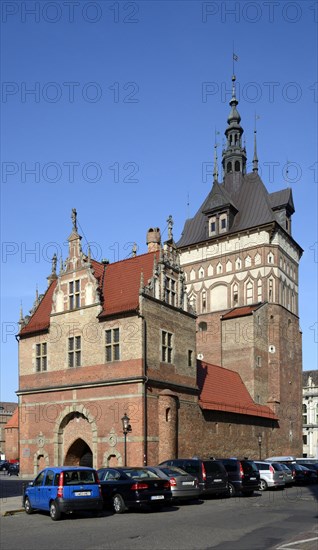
[{"xmin": 147, "ymin": 466, "xmax": 200, "ymax": 500}]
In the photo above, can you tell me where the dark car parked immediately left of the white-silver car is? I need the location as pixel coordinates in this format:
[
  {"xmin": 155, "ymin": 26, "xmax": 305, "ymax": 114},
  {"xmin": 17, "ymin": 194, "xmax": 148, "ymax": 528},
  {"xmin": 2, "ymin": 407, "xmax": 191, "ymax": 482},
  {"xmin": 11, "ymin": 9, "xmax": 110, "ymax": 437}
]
[{"xmin": 220, "ymin": 458, "xmax": 260, "ymax": 496}]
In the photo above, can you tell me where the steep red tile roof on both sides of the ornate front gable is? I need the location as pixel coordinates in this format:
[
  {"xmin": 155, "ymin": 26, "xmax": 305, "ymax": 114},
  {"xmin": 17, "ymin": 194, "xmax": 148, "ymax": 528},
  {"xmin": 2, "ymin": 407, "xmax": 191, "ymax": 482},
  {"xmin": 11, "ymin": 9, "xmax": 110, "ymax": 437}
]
[{"xmin": 20, "ymin": 252, "xmax": 159, "ymax": 337}]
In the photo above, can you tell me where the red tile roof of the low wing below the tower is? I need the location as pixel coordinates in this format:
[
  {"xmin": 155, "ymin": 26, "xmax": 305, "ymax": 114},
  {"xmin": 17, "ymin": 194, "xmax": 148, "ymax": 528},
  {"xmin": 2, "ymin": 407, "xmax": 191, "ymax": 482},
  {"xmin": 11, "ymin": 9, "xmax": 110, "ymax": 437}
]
[{"xmin": 197, "ymin": 361, "xmax": 277, "ymax": 420}]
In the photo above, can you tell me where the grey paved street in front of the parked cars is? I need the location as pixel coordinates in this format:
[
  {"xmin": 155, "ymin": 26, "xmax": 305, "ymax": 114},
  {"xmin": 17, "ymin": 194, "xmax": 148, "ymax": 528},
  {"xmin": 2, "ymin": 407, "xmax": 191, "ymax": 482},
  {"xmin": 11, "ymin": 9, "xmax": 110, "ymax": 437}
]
[{"xmin": 0, "ymin": 476, "xmax": 318, "ymax": 550}]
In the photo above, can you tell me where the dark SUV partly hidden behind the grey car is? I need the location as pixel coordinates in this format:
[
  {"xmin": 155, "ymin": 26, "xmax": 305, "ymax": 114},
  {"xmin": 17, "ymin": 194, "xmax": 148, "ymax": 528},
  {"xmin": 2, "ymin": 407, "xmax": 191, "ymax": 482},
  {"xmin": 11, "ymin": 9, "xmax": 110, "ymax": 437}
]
[{"xmin": 159, "ymin": 458, "xmax": 229, "ymax": 496}]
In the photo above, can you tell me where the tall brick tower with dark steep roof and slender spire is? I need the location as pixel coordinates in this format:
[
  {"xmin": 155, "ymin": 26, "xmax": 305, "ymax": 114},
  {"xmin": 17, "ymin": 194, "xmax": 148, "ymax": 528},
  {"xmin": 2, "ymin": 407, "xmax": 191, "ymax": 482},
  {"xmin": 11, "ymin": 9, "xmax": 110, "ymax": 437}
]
[{"xmin": 177, "ymin": 76, "xmax": 302, "ymax": 456}]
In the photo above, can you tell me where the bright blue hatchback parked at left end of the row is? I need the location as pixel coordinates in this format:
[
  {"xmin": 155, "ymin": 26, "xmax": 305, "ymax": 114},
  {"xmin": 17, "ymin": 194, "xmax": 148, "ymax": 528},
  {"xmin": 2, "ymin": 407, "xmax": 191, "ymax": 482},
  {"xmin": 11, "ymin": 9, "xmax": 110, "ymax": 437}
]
[{"xmin": 23, "ymin": 466, "xmax": 103, "ymax": 521}]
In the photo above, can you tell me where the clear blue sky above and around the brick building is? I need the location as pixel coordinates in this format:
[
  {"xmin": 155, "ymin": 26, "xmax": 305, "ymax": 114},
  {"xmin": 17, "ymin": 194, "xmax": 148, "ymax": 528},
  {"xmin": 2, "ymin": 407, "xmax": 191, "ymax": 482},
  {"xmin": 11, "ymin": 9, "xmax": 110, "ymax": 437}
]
[{"xmin": 0, "ymin": 0, "xmax": 318, "ymax": 401}]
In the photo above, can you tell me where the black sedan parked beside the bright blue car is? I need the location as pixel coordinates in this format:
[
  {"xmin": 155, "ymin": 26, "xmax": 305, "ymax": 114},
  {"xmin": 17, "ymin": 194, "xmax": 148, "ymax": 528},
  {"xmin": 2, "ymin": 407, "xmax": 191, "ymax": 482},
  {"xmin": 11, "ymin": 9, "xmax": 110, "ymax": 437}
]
[{"xmin": 98, "ymin": 467, "xmax": 172, "ymax": 514}]
